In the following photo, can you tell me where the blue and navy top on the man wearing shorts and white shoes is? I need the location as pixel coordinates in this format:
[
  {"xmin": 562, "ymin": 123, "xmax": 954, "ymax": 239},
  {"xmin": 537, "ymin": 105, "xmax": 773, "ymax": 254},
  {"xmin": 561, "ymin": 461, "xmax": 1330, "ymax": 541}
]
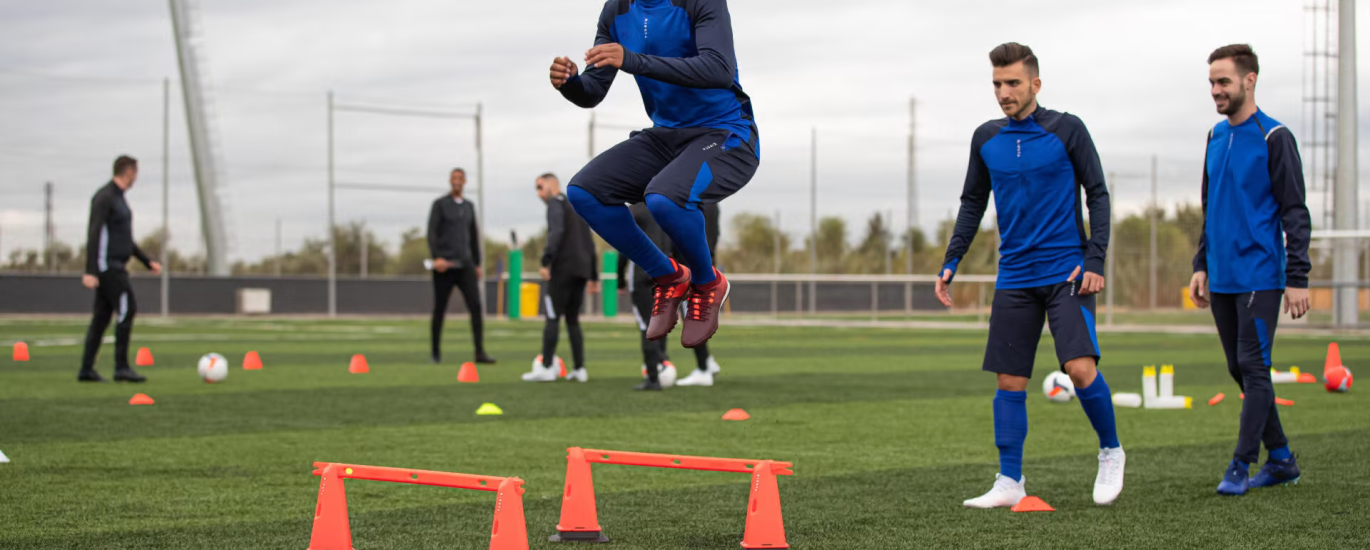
[{"xmin": 944, "ymin": 107, "xmax": 1108, "ymax": 289}]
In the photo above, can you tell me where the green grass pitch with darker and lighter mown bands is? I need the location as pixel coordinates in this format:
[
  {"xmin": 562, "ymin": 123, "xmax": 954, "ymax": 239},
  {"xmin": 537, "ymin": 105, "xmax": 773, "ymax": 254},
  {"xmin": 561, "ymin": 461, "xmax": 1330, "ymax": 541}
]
[{"xmin": 0, "ymin": 320, "xmax": 1370, "ymax": 550}]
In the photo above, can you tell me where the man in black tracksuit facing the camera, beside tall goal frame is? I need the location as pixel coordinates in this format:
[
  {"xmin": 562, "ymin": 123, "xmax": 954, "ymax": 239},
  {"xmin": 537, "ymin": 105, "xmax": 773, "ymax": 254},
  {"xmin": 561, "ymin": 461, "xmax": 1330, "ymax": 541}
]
[{"xmin": 427, "ymin": 169, "xmax": 495, "ymax": 363}]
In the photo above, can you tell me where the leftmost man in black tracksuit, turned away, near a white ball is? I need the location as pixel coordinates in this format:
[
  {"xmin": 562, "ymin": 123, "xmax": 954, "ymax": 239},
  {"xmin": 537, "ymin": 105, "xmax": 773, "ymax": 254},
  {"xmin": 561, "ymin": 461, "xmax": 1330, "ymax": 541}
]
[{"xmin": 77, "ymin": 156, "xmax": 162, "ymax": 383}]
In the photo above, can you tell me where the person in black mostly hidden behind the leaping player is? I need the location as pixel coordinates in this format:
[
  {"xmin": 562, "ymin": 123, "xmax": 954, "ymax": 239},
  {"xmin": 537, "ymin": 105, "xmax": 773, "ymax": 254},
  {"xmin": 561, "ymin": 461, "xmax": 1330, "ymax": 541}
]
[{"xmin": 618, "ymin": 203, "xmax": 719, "ymax": 391}]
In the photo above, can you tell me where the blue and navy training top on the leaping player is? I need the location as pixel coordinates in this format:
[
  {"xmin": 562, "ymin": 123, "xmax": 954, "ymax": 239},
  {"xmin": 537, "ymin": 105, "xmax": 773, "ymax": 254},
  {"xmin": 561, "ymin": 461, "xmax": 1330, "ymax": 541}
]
[{"xmin": 562, "ymin": 0, "xmax": 752, "ymax": 144}]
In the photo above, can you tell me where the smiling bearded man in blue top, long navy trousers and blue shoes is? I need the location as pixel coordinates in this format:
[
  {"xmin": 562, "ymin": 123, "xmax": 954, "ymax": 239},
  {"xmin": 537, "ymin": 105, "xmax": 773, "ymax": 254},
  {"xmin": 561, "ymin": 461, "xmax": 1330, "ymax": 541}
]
[{"xmin": 1189, "ymin": 44, "xmax": 1312, "ymax": 495}]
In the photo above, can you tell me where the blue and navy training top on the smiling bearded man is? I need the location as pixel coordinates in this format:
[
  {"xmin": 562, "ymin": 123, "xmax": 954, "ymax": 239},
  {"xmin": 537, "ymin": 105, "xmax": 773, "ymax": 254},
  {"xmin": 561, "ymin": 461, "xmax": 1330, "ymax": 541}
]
[{"xmin": 1195, "ymin": 110, "xmax": 1312, "ymax": 294}]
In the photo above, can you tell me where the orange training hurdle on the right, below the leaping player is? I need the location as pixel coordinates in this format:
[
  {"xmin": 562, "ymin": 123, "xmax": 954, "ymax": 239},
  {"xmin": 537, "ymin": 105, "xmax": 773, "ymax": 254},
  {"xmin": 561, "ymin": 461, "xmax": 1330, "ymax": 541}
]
[{"xmin": 548, "ymin": 447, "xmax": 795, "ymax": 549}]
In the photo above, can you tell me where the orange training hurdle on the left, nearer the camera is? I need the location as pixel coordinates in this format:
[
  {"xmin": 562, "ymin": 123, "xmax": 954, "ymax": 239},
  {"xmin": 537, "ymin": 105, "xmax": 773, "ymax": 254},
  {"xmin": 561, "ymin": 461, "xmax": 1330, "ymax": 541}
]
[{"xmin": 310, "ymin": 462, "xmax": 527, "ymax": 550}]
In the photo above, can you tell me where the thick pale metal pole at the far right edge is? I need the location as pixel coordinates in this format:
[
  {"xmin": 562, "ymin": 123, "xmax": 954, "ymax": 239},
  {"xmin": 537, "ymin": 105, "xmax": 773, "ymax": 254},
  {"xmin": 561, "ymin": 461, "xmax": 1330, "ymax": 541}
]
[{"xmin": 1332, "ymin": 0, "xmax": 1360, "ymax": 328}]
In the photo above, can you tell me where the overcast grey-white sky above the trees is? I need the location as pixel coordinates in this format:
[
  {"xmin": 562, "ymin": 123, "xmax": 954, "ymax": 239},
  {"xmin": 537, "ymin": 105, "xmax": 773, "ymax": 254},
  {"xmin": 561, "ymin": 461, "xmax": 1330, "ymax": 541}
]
[{"xmin": 0, "ymin": 0, "xmax": 1370, "ymax": 259}]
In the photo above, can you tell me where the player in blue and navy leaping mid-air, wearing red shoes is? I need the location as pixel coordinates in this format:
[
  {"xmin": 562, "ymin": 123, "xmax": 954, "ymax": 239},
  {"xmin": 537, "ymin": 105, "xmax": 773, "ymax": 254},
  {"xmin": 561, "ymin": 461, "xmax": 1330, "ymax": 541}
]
[{"xmin": 551, "ymin": 0, "xmax": 760, "ymax": 347}]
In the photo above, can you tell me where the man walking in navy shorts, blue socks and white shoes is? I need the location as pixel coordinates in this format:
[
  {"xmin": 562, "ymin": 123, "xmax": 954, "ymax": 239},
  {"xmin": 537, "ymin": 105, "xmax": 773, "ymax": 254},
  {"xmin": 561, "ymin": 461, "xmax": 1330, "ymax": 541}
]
[{"xmin": 937, "ymin": 43, "xmax": 1126, "ymax": 507}]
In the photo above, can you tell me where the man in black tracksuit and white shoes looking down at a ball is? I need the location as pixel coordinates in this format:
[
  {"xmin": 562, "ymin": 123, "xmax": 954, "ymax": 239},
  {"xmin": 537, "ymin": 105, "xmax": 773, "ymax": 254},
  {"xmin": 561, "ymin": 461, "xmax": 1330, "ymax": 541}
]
[{"xmin": 523, "ymin": 174, "xmax": 599, "ymax": 381}]
